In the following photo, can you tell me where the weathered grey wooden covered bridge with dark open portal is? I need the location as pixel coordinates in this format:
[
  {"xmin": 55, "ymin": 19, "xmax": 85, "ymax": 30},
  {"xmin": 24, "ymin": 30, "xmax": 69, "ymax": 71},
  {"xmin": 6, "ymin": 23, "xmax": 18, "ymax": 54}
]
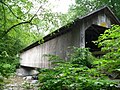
[{"xmin": 20, "ymin": 7, "xmax": 119, "ymax": 68}]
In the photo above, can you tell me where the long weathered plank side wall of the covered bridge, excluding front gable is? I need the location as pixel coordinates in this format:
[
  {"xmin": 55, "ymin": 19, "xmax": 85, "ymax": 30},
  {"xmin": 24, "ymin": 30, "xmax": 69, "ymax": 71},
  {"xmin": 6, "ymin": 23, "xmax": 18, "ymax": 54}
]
[{"xmin": 20, "ymin": 24, "xmax": 79, "ymax": 68}]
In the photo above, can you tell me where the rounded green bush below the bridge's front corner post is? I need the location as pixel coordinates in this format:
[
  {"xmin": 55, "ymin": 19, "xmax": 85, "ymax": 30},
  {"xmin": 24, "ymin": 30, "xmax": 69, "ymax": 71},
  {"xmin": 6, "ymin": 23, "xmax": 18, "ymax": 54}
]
[{"xmin": 70, "ymin": 47, "xmax": 94, "ymax": 68}]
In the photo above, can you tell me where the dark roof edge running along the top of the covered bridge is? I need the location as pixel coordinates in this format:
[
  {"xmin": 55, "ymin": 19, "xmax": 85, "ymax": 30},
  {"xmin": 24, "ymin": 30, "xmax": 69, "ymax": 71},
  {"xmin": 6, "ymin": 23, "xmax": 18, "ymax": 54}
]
[{"xmin": 20, "ymin": 6, "xmax": 120, "ymax": 53}]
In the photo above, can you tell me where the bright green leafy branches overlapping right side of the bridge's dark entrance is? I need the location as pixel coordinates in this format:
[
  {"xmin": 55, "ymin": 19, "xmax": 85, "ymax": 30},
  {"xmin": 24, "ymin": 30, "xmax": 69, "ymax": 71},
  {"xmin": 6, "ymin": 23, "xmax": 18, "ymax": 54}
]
[{"xmin": 98, "ymin": 25, "xmax": 120, "ymax": 60}]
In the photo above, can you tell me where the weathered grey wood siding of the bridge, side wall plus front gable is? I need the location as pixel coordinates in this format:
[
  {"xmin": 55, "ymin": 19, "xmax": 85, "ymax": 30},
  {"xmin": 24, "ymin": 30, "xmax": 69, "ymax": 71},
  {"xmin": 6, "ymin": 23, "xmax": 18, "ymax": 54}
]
[{"xmin": 20, "ymin": 8, "xmax": 117, "ymax": 68}]
